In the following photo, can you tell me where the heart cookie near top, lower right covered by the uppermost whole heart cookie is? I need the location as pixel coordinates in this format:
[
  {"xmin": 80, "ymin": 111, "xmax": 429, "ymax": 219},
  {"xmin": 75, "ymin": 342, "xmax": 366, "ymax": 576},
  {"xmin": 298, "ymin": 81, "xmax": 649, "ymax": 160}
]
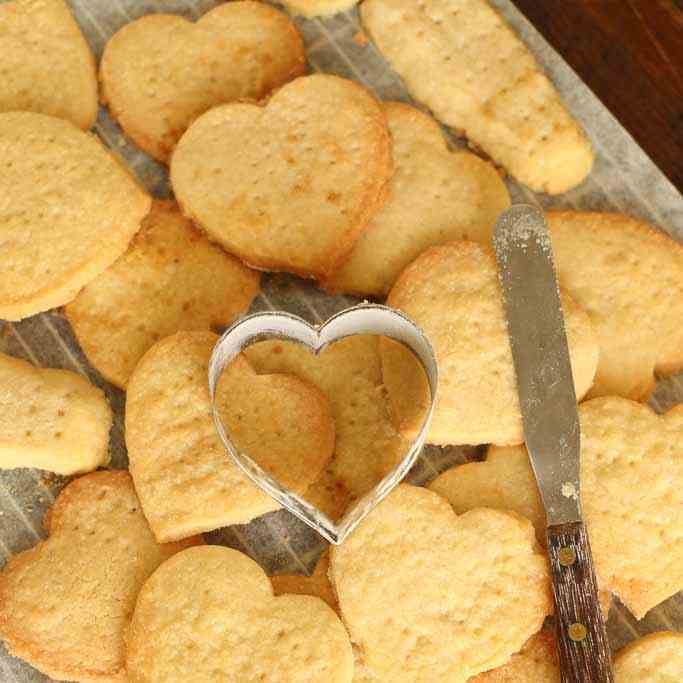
[{"xmin": 100, "ymin": 1, "xmax": 306, "ymax": 161}]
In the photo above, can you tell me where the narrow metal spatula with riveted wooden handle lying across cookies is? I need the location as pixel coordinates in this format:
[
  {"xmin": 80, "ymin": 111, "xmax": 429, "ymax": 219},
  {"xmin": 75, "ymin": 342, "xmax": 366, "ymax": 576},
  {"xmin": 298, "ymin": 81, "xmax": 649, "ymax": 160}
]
[{"xmin": 493, "ymin": 205, "xmax": 614, "ymax": 683}]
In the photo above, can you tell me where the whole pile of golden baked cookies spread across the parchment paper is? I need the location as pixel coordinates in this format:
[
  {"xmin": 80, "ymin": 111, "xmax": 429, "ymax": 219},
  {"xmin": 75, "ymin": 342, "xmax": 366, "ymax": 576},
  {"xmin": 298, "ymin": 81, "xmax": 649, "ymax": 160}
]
[{"xmin": 0, "ymin": 0, "xmax": 683, "ymax": 683}]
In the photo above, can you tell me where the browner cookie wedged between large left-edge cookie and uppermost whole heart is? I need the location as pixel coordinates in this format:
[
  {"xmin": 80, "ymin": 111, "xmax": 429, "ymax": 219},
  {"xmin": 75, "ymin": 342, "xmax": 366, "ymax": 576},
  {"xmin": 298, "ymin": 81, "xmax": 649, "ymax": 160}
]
[{"xmin": 66, "ymin": 201, "xmax": 259, "ymax": 388}]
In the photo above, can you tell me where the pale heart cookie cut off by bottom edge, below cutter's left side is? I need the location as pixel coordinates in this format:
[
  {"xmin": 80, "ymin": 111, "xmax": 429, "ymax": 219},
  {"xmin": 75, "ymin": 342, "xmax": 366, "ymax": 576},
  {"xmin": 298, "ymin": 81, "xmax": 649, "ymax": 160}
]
[{"xmin": 126, "ymin": 546, "xmax": 353, "ymax": 683}]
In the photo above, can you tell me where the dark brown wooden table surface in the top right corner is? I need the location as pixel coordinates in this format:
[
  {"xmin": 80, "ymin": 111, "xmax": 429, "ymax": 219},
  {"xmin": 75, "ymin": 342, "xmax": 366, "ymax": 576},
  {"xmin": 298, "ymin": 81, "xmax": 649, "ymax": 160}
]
[{"xmin": 513, "ymin": 0, "xmax": 683, "ymax": 192}]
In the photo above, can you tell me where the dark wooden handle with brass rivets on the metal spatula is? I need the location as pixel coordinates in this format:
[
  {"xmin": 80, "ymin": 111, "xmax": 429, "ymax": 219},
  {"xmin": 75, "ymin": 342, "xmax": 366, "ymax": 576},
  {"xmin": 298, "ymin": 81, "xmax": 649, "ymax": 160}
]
[{"xmin": 548, "ymin": 522, "xmax": 614, "ymax": 683}]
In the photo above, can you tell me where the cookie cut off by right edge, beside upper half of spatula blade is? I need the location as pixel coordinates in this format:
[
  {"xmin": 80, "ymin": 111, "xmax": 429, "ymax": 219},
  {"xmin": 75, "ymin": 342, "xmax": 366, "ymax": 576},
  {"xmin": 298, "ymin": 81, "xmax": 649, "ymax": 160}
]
[{"xmin": 548, "ymin": 211, "xmax": 683, "ymax": 400}]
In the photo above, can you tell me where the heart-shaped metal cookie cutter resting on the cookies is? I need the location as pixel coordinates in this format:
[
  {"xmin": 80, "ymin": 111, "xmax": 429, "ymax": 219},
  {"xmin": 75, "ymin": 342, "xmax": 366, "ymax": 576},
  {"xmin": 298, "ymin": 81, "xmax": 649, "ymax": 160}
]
[{"xmin": 209, "ymin": 304, "xmax": 439, "ymax": 545}]
